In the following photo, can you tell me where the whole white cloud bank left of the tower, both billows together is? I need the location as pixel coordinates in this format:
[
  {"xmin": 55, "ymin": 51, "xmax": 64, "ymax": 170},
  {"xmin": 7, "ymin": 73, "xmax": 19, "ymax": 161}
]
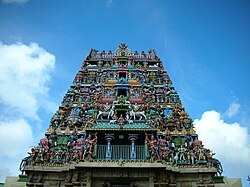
[{"xmin": 0, "ymin": 42, "xmax": 55, "ymax": 182}]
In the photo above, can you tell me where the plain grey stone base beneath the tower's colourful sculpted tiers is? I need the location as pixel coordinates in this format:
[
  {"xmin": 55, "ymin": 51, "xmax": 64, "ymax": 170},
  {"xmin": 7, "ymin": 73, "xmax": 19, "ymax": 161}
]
[{"xmin": 21, "ymin": 161, "xmax": 242, "ymax": 187}]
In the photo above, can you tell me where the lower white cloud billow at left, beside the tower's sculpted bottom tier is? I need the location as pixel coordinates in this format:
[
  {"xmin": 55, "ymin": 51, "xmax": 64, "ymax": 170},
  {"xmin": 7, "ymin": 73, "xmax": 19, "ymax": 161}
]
[{"xmin": 0, "ymin": 119, "xmax": 35, "ymax": 182}]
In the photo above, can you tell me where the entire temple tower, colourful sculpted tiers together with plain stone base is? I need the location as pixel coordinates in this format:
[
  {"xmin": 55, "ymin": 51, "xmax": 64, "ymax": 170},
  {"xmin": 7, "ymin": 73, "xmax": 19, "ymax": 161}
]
[{"xmin": 20, "ymin": 44, "xmax": 222, "ymax": 187}]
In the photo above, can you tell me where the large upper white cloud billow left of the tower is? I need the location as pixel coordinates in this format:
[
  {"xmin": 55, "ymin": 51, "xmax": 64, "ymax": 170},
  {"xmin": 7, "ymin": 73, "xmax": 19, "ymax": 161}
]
[{"xmin": 0, "ymin": 42, "xmax": 55, "ymax": 119}]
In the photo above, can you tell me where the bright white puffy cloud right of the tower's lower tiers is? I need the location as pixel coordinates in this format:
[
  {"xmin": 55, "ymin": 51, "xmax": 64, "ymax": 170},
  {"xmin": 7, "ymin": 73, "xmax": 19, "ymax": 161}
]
[{"xmin": 194, "ymin": 110, "xmax": 250, "ymax": 177}]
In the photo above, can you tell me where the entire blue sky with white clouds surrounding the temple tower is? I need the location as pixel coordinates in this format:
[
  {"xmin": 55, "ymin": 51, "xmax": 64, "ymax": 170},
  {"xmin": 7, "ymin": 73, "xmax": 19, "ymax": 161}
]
[{"xmin": 0, "ymin": 0, "xmax": 250, "ymax": 185}]
